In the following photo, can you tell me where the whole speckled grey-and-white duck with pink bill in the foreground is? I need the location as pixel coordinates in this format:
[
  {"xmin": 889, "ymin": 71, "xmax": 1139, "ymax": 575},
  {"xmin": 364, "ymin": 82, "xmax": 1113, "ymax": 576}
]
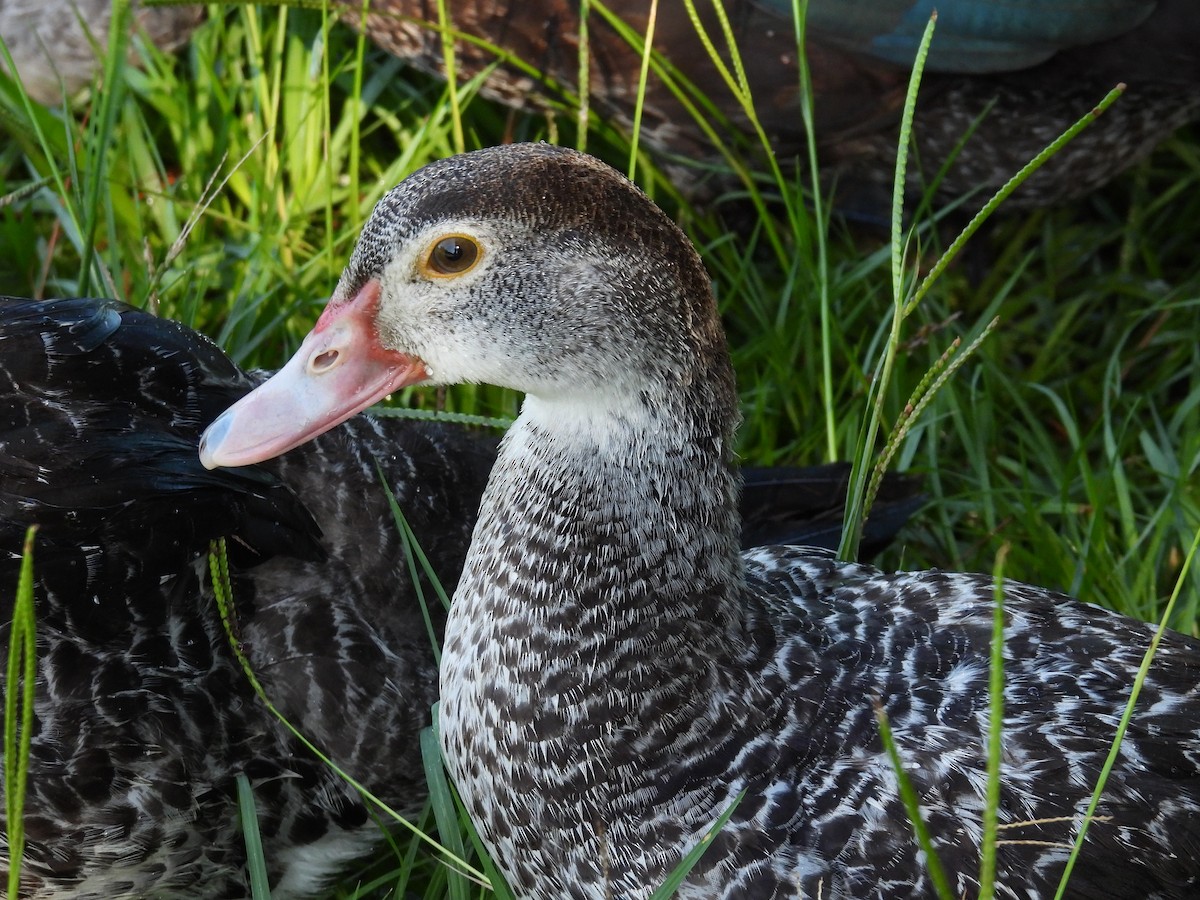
[{"xmin": 202, "ymin": 145, "xmax": 1200, "ymax": 900}]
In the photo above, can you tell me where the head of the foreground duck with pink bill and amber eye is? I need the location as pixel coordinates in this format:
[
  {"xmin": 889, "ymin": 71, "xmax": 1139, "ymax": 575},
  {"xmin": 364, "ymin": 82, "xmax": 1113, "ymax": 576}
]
[{"xmin": 200, "ymin": 144, "xmax": 734, "ymax": 468}]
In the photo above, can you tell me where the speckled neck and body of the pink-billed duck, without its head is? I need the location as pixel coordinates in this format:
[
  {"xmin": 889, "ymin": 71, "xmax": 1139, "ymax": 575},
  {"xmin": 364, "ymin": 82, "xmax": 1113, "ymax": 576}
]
[{"xmin": 440, "ymin": 321, "xmax": 1200, "ymax": 900}]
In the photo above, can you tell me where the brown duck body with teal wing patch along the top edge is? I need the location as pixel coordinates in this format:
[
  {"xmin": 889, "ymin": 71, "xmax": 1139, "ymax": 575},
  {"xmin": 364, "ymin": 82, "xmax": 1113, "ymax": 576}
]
[{"xmin": 344, "ymin": 0, "xmax": 1200, "ymax": 214}]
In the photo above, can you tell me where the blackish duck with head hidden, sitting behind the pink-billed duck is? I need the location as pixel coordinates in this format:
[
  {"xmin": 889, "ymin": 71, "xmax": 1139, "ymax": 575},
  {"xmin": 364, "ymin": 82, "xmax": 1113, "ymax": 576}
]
[{"xmin": 0, "ymin": 299, "xmax": 919, "ymax": 900}]
